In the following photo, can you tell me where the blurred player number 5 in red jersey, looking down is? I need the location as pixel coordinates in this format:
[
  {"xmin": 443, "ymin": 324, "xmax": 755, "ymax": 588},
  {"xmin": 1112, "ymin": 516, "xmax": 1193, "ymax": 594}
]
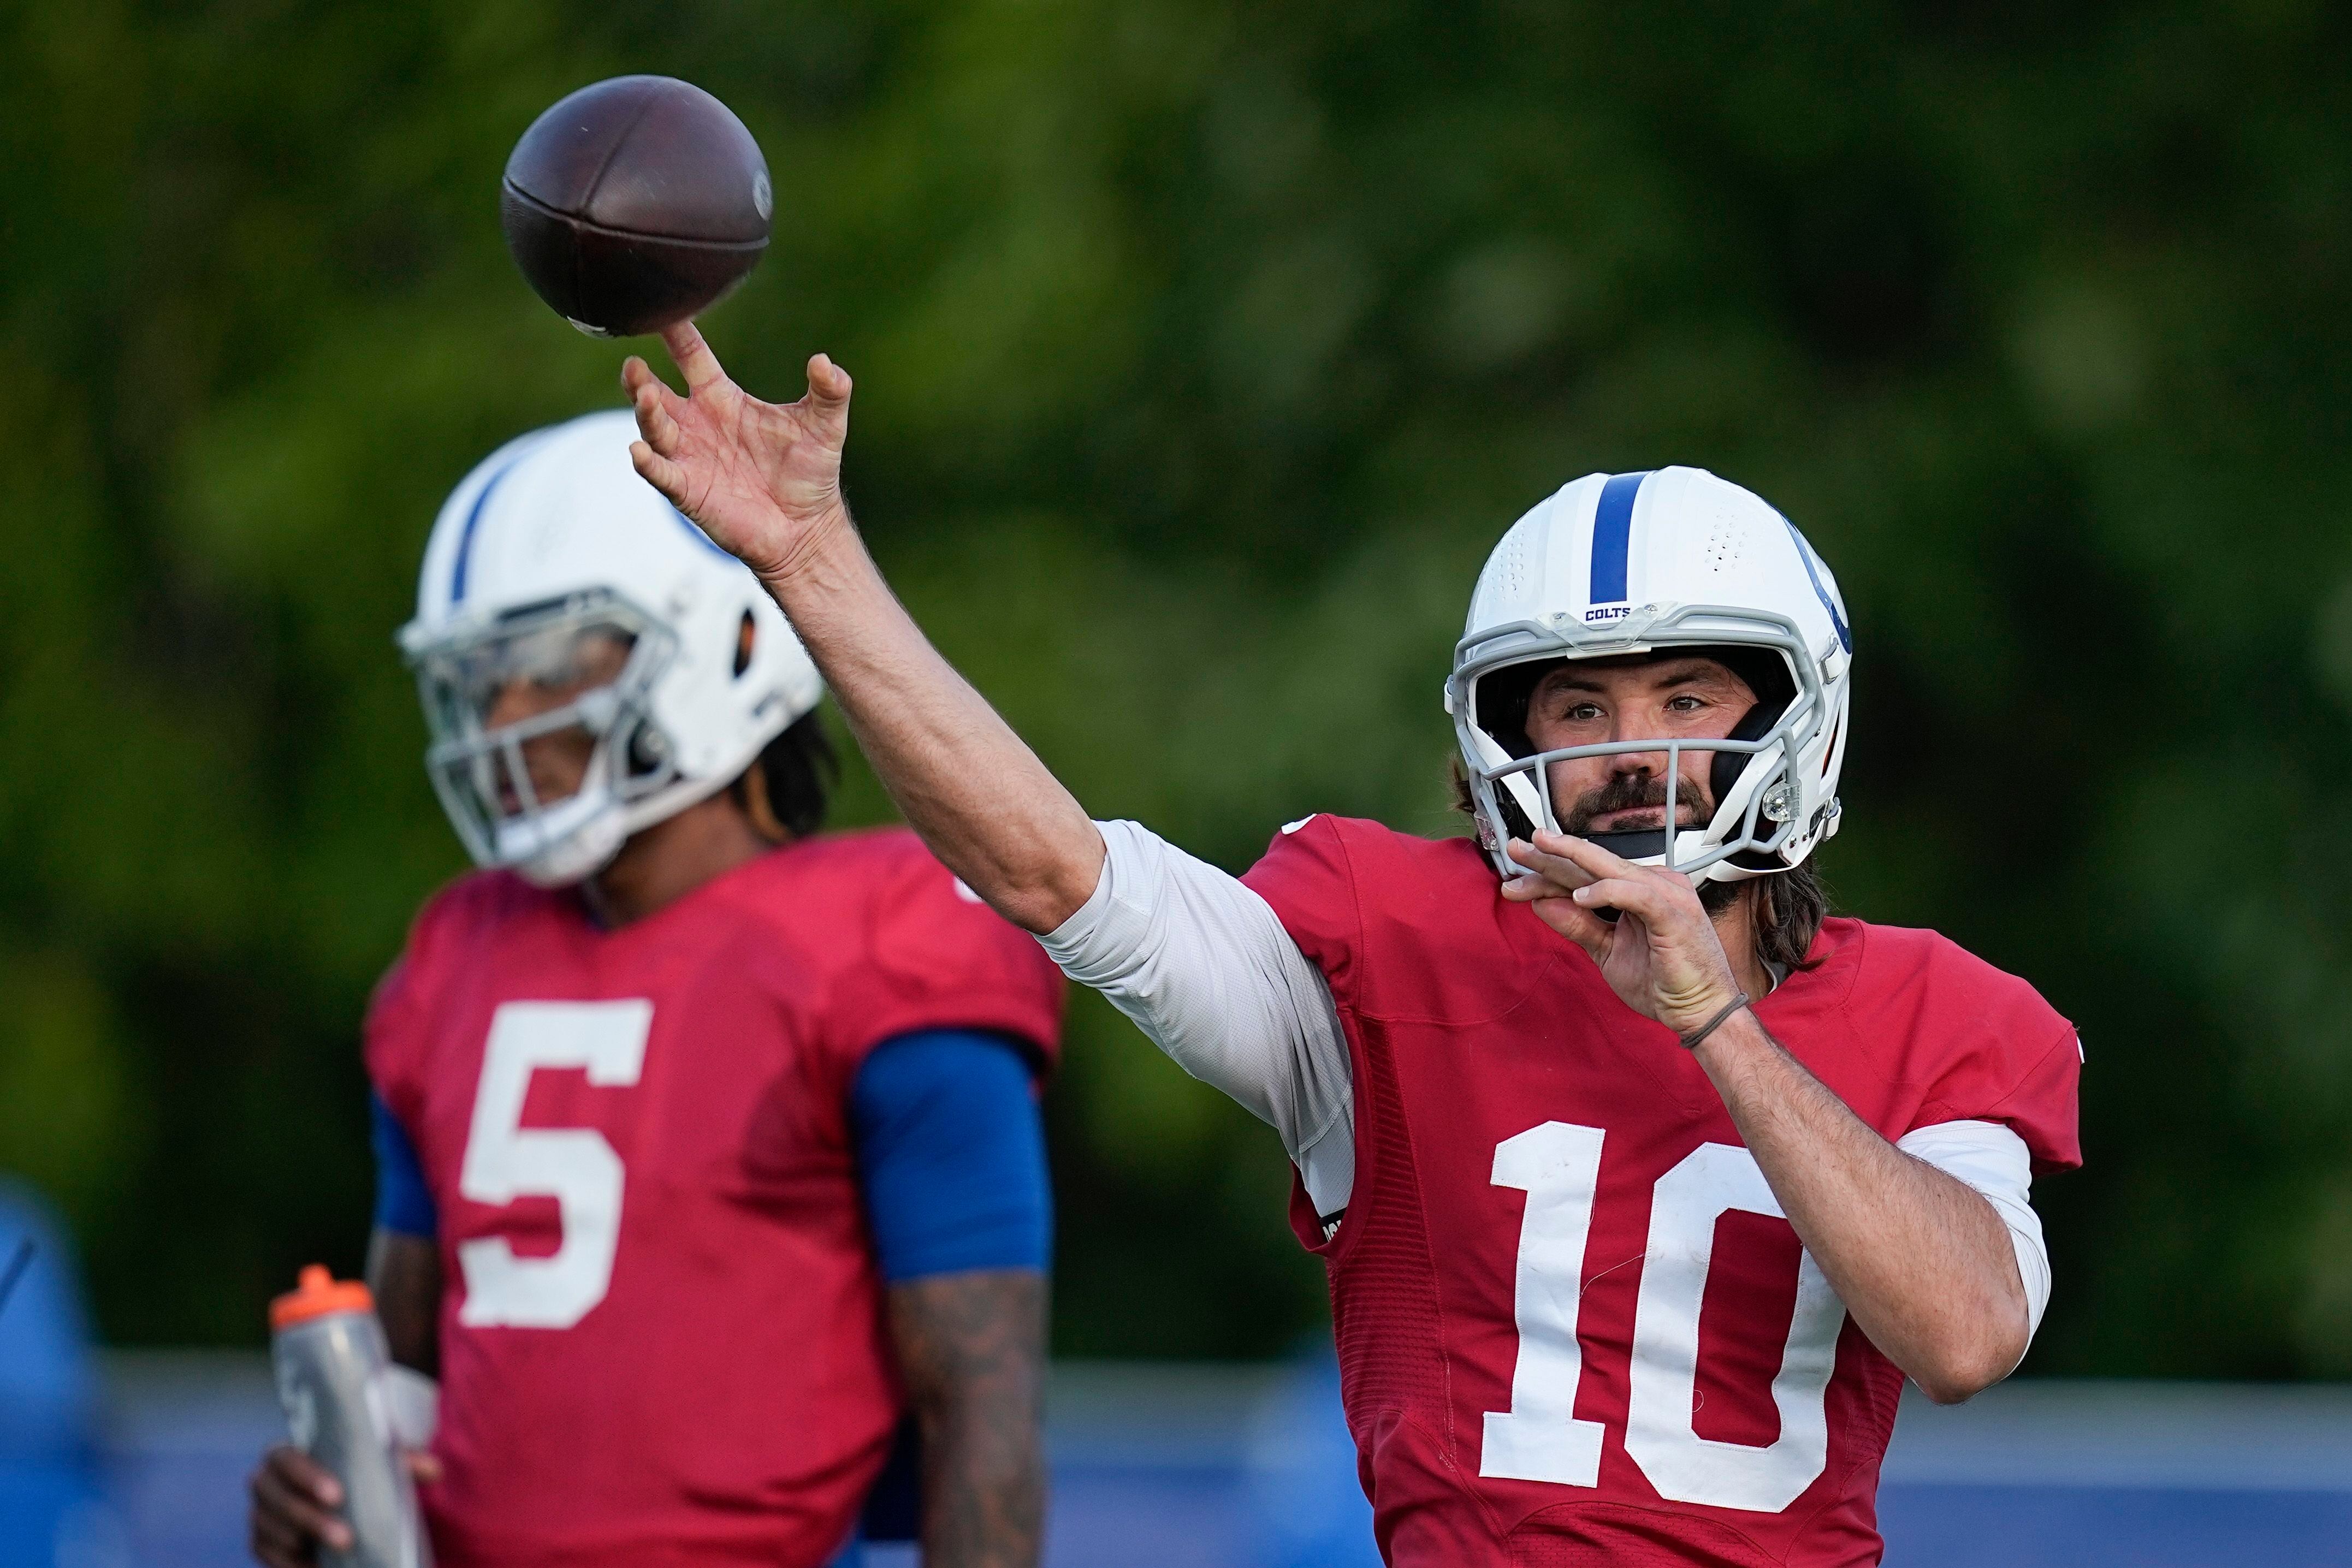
[{"xmin": 252, "ymin": 412, "xmax": 1061, "ymax": 1568}]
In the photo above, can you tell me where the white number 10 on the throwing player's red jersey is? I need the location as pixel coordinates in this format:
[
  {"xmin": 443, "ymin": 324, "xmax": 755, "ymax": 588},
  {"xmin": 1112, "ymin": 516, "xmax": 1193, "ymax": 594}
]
[{"xmin": 1479, "ymin": 1121, "xmax": 1846, "ymax": 1514}]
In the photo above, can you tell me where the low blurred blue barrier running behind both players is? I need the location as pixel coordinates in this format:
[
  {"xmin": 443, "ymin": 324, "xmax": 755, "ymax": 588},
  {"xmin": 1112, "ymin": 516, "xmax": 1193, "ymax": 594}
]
[{"xmin": 27, "ymin": 1354, "xmax": 2352, "ymax": 1568}]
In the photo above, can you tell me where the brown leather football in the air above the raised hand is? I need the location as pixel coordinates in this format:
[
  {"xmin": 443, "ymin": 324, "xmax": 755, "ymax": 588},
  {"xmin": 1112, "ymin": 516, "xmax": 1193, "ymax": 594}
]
[{"xmin": 499, "ymin": 75, "xmax": 776, "ymax": 338}]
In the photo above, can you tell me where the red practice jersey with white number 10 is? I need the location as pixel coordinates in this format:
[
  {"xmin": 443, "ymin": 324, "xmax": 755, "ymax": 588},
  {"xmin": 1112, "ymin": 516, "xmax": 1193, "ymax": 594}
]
[{"xmin": 1247, "ymin": 816, "xmax": 2082, "ymax": 1568}]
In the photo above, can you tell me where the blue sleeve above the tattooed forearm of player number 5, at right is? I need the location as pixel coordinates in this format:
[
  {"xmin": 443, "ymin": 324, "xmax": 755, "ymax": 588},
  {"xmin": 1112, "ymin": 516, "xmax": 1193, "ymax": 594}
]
[{"xmin": 849, "ymin": 1030, "xmax": 1054, "ymax": 1284}]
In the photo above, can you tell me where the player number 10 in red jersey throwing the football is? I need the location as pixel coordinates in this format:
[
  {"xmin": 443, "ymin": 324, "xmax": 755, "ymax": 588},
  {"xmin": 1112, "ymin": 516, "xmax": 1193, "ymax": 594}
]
[{"xmin": 623, "ymin": 327, "xmax": 2079, "ymax": 1566}]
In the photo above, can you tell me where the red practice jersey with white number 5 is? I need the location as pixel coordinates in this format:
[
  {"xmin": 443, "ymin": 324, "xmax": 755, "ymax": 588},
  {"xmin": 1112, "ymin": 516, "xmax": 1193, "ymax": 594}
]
[{"xmin": 367, "ymin": 830, "xmax": 1061, "ymax": 1568}]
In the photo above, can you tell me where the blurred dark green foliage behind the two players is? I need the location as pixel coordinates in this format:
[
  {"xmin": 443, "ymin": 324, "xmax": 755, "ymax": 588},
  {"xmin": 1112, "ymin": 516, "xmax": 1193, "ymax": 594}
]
[{"xmin": 0, "ymin": 0, "xmax": 2352, "ymax": 1377}]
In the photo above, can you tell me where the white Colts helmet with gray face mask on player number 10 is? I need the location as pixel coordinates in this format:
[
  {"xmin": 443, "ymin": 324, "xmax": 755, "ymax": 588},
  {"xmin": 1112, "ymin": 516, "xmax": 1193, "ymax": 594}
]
[{"xmin": 1447, "ymin": 468, "xmax": 1853, "ymax": 882}]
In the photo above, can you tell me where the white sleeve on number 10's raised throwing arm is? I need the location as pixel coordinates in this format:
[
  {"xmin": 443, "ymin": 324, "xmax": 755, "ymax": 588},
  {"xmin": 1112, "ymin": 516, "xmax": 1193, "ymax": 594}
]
[{"xmin": 1037, "ymin": 823, "xmax": 1355, "ymax": 1217}]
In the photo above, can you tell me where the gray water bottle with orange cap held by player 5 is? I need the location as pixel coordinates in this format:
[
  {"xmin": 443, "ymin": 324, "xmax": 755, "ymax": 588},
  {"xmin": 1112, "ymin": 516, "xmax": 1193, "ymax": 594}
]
[{"xmin": 270, "ymin": 1262, "xmax": 433, "ymax": 1568}]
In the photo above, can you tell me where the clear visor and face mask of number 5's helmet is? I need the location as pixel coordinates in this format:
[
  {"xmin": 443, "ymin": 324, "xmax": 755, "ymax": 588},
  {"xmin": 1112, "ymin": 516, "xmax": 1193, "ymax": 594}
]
[{"xmin": 405, "ymin": 590, "xmax": 675, "ymax": 884}]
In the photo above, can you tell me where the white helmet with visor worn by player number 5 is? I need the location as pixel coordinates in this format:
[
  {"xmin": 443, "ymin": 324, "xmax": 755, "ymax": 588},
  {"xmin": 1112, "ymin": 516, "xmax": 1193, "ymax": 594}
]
[{"xmin": 400, "ymin": 409, "xmax": 823, "ymax": 886}]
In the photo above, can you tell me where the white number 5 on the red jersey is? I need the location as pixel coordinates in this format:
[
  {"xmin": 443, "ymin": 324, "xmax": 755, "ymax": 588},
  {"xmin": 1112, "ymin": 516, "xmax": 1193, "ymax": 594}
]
[{"xmin": 457, "ymin": 999, "xmax": 654, "ymax": 1328}]
